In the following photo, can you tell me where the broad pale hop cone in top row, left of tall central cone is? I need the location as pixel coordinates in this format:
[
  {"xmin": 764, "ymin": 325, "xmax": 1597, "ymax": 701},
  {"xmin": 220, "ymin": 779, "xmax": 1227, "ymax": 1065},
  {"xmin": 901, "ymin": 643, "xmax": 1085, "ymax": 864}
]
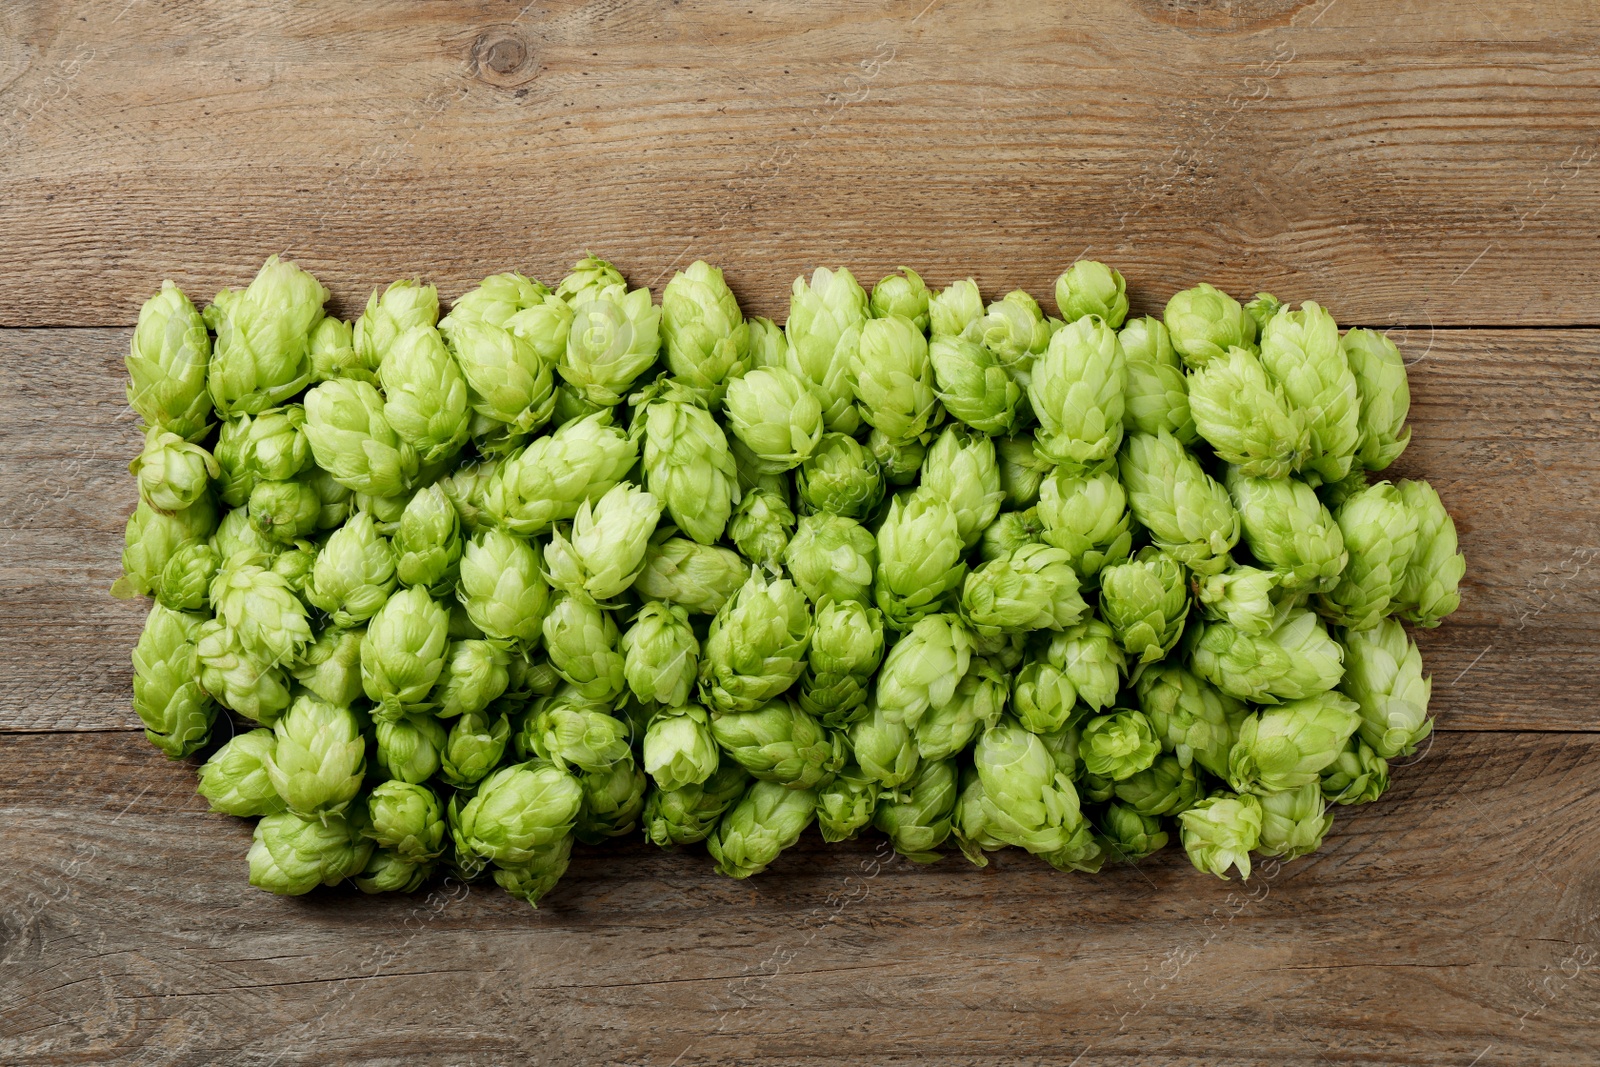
[{"xmin": 555, "ymin": 285, "xmax": 661, "ymax": 406}]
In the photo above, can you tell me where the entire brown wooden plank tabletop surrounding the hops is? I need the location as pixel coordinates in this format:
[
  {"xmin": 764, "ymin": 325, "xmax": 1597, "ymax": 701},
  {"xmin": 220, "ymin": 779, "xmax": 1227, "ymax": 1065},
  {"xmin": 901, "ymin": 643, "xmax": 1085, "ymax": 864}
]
[{"xmin": 0, "ymin": 0, "xmax": 1600, "ymax": 1067}]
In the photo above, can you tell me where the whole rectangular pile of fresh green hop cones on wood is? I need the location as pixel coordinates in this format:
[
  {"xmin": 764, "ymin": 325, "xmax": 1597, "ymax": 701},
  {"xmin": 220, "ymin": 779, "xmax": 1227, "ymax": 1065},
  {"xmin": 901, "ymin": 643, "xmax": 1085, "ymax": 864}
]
[{"xmin": 114, "ymin": 258, "xmax": 1466, "ymax": 904}]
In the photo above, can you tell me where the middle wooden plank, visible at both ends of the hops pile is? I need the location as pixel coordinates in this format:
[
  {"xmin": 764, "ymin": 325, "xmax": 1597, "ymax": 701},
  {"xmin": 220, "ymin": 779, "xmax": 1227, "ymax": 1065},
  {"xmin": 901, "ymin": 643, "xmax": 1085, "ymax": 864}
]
[{"xmin": 0, "ymin": 330, "xmax": 1600, "ymax": 729}]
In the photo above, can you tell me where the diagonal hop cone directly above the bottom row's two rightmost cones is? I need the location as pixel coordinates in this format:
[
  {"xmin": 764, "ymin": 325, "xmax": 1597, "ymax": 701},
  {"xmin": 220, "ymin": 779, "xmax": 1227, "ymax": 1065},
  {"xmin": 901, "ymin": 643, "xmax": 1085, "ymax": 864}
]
[{"xmin": 1227, "ymin": 693, "xmax": 1362, "ymax": 793}]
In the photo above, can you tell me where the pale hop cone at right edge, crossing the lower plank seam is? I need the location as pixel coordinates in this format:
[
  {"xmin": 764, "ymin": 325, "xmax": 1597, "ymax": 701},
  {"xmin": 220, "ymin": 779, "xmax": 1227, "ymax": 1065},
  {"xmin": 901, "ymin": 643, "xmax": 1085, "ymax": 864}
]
[{"xmin": 1339, "ymin": 619, "xmax": 1434, "ymax": 760}]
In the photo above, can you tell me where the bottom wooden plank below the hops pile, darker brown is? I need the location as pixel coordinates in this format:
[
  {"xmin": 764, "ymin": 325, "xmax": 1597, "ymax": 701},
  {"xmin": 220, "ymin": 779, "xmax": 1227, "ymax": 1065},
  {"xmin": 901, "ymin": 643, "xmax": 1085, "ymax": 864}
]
[{"xmin": 0, "ymin": 734, "xmax": 1600, "ymax": 1067}]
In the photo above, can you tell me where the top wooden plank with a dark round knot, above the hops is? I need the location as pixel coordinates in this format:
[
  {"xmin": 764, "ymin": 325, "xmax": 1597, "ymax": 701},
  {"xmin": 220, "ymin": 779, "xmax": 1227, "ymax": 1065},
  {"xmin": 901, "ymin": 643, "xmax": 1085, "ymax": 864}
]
[{"xmin": 0, "ymin": 0, "xmax": 1600, "ymax": 325}]
